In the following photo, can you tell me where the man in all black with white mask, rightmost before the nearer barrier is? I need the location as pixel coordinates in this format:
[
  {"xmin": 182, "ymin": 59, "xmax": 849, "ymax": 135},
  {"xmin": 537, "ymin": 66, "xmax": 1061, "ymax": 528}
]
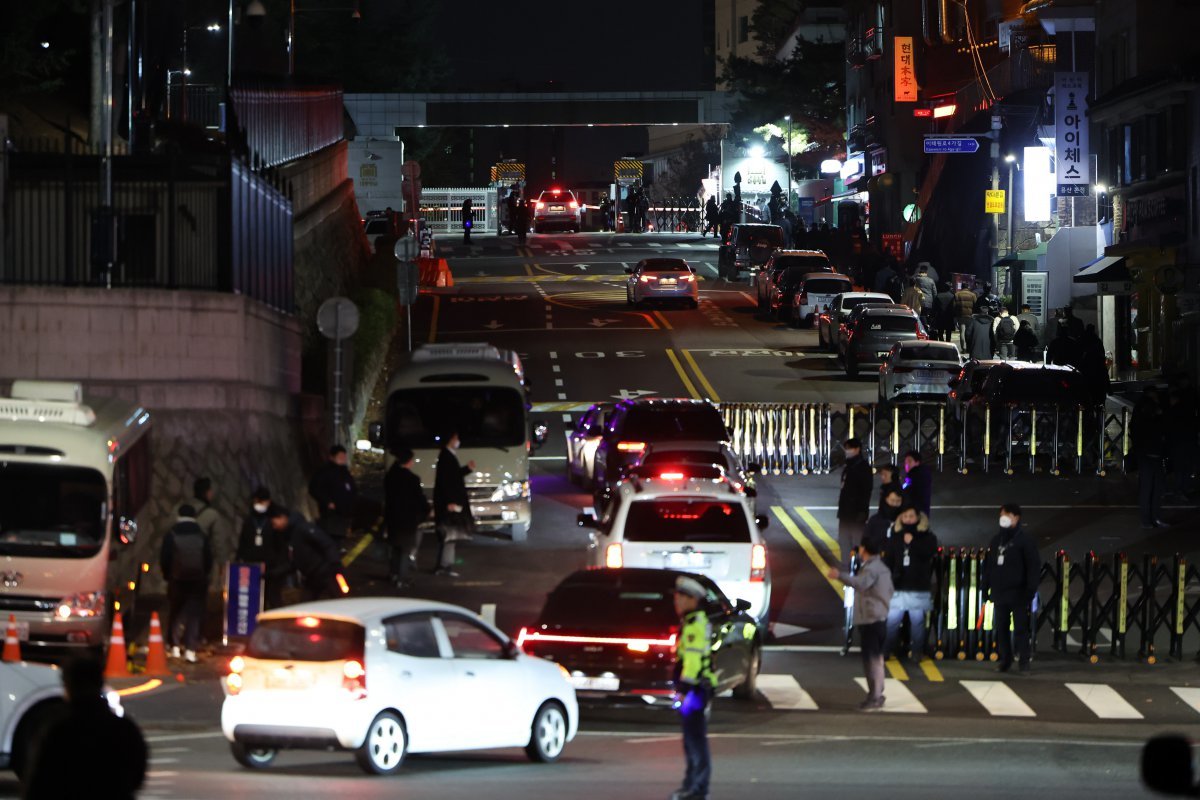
[{"xmin": 971, "ymin": 503, "xmax": 1042, "ymax": 672}]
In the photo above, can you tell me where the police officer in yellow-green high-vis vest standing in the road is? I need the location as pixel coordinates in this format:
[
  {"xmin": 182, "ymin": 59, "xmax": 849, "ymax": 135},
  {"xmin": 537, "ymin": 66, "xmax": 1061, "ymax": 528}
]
[{"xmin": 672, "ymin": 577, "xmax": 716, "ymax": 800}]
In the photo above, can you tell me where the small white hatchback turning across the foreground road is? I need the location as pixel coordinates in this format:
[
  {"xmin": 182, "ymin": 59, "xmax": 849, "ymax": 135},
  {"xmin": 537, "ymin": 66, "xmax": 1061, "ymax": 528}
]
[{"xmin": 221, "ymin": 597, "xmax": 580, "ymax": 775}]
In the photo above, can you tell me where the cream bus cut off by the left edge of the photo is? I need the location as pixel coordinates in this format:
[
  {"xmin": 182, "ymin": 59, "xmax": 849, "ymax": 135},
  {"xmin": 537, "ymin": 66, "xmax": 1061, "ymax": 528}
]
[{"xmin": 0, "ymin": 380, "xmax": 151, "ymax": 657}]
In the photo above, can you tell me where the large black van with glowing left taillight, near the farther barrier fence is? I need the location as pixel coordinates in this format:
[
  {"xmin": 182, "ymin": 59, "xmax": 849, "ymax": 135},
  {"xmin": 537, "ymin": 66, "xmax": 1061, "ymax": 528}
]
[{"xmin": 593, "ymin": 399, "xmax": 730, "ymax": 509}]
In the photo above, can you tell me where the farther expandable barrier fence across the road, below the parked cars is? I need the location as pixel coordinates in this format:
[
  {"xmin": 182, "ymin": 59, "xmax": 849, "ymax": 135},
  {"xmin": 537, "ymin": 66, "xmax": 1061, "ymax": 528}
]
[{"xmin": 720, "ymin": 403, "xmax": 1129, "ymax": 475}]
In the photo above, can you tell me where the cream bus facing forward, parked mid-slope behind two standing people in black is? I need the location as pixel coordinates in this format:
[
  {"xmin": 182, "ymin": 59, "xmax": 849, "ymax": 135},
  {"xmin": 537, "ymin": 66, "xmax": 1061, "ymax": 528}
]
[{"xmin": 371, "ymin": 343, "xmax": 546, "ymax": 541}]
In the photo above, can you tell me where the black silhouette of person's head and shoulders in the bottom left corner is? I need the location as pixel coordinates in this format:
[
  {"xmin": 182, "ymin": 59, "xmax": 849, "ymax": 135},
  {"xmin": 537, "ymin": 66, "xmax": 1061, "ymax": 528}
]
[{"xmin": 23, "ymin": 656, "xmax": 149, "ymax": 800}]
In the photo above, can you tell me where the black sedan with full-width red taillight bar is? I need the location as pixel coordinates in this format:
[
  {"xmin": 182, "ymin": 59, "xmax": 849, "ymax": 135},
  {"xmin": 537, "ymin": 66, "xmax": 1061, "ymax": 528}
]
[{"xmin": 517, "ymin": 569, "xmax": 762, "ymax": 703}]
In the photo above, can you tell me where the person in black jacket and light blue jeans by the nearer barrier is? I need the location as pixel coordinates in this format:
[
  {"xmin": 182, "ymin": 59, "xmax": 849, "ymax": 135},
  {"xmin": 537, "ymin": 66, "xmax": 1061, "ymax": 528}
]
[{"xmin": 883, "ymin": 504, "xmax": 937, "ymax": 661}]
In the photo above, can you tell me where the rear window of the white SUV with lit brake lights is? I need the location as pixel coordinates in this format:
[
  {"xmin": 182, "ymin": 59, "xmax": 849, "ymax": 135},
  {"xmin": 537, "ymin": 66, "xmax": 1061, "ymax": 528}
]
[{"xmin": 625, "ymin": 498, "xmax": 750, "ymax": 543}]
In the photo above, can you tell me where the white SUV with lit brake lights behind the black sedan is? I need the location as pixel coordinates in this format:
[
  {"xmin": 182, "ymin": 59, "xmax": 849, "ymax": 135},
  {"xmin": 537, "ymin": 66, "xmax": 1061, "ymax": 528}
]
[{"xmin": 580, "ymin": 464, "xmax": 770, "ymax": 624}]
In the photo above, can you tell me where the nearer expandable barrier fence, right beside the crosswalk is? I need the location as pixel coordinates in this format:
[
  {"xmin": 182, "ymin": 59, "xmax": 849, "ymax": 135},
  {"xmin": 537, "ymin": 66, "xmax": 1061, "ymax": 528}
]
[{"xmin": 845, "ymin": 547, "xmax": 1200, "ymax": 663}]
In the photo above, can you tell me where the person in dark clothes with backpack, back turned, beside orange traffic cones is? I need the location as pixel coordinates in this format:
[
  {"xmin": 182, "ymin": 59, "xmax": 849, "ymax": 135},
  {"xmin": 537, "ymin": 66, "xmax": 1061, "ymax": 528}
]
[{"xmin": 158, "ymin": 504, "xmax": 212, "ymax": 663}]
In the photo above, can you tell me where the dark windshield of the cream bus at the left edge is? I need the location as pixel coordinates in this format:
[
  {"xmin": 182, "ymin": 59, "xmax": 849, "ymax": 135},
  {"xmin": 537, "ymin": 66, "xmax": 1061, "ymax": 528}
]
[{"xmin": 0, "ymin": 462, "xmax": 108, "ymax": 558}]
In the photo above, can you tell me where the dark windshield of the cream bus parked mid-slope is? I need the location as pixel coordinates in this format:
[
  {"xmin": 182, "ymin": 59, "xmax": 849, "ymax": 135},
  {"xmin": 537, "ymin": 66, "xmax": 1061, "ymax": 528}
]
[{"xmin": 388, "ymin": 386, "xmax": 526, "ymax": 450}]
